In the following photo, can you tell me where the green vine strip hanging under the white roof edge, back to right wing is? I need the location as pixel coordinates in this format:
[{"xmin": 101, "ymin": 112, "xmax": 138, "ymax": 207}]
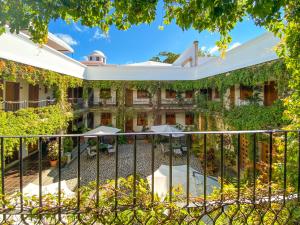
[{"xmin": 84, "ymin": 60, "xmax": 289, "ymax": 93}]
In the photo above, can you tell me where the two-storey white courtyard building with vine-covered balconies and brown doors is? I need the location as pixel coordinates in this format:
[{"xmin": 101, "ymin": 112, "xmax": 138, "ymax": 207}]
[{"xmin": 0, "ymin": 28, "xmax": 279, "ymax": 163}]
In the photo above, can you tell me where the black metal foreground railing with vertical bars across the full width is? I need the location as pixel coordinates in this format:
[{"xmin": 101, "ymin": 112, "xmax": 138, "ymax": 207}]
[{"xmin": 0, "ymin": 130, "xmax": 300, "ymax": 224}]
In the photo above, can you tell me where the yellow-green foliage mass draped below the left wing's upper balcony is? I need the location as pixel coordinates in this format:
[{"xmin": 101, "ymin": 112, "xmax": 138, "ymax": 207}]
[{"xmin": 0, "ymin": 105, "xmax": 72, "ymax": 157}]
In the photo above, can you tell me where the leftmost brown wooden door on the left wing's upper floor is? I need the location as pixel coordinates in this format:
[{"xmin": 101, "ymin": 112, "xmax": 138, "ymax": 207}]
[{"xmin": 5, "ymin": 81, "xmax": 20, "ymax": 111}]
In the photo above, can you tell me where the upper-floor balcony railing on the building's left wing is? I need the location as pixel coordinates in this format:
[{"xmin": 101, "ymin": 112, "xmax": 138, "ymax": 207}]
[{"xmin": 0, "ymin": 99, "xmax": 56, "ymax": 112}]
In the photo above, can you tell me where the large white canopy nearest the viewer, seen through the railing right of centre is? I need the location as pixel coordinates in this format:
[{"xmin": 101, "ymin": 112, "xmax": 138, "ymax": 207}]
[{"xmin": 147, "ymin": 165, "xmax": 220, "ymax": 199}]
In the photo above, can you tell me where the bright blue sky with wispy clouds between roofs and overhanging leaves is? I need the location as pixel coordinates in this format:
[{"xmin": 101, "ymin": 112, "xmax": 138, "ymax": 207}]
[{"xmin": 49, "ymin": 17, "xmax": 265, "ymax": 64}]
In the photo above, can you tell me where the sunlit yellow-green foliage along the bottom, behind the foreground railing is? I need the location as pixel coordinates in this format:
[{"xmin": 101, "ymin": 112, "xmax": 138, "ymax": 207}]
[{"xmin": 0, "ymin": 176, "xmax": 299, "ymax": 225}]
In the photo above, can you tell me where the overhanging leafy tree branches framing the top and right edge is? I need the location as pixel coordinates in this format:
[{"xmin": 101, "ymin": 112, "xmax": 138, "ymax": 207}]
[{"xmin": 0, "ymin": 0, "xmax": 300, "ymax": 127}]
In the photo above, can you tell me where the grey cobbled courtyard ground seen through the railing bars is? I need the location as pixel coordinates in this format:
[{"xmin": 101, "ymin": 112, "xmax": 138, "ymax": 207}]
[{"xmin": 58, "ymin": 140, "xmax": 202, "ymax": 189}]
